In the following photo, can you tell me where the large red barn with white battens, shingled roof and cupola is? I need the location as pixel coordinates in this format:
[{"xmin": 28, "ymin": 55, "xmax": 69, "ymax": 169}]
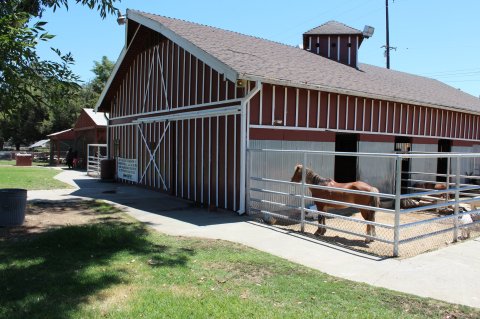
[{"xmin": 96, "ymin": 10, "xmax": 480, "ymax": 212}]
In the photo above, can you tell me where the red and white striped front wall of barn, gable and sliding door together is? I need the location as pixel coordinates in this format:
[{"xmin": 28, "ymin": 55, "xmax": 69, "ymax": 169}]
[{"xmin": 109, "ymin": 29, "xmax": 244, "ymax": 210}]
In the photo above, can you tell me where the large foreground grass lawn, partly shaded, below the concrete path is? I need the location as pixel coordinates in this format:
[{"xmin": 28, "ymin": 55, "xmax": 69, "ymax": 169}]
[{"xmin": 0, "ymin": 205, "xmax": 480, "ymax": 318}]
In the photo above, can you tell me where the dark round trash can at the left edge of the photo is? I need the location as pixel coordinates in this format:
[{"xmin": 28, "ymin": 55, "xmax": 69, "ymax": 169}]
[{"xmin": 0, "ymin": 188, "xmax": 27, "ymax": 226}]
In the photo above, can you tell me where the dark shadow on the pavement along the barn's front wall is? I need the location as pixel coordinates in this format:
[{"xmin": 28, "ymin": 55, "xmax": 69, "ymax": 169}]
[{"xmin": 71, "ymin": 179, "xmax": 248, "ymax": 226}]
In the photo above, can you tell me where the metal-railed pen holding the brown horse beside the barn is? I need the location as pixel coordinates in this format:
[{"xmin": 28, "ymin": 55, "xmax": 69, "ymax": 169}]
[{"xmin": 247, "ymin": 148, "xmax": 480, "ymax": 257}]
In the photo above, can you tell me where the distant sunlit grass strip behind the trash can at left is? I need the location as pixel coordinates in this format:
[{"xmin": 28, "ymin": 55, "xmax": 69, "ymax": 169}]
[{"xmin": 0, "ymin": 166, "xmax": 71, "ymax": 190}]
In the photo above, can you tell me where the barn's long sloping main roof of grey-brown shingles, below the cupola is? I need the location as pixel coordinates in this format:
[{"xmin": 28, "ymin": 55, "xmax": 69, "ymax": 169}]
[{"xmin": 120, "ymin": 10, "xmax": 480, "ymax": 112}]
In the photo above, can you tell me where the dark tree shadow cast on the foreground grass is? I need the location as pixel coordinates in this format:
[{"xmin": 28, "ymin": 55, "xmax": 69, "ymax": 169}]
[{"xmin": 0, "ymin": 211, "xmax": 195, "ymax": 318}]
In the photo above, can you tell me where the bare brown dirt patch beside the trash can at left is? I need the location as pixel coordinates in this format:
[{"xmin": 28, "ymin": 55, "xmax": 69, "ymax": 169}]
[{"xmin": 0, "ymin": 200, "xmax": 122, "ymax": 241}]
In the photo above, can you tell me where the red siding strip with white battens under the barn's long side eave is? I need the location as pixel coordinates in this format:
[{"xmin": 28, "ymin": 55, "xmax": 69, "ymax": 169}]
[{"xmin": 249, "ymin": 83, "xmax": 480, "ymax": 140}]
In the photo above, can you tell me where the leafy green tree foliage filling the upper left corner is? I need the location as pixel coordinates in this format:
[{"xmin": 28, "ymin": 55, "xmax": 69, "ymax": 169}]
[{"xmin": 0, "ymin": 0, "xmax": 118, "ymax": 149}]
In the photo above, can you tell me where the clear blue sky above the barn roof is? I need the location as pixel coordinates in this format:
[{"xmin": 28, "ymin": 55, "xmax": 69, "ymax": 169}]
[{"xmin": 36, "ymin": 0, "xmax": 480, "ymax": 97}]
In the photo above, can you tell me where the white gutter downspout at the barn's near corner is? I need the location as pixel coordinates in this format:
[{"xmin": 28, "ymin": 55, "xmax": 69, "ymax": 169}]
[{"xmin": 237, "ymin": 81, "xmax": 262, "ymax": 215}]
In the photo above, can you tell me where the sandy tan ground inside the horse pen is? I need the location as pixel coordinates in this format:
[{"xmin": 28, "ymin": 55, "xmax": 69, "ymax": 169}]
[{"xmin": 253, "ymin": 207, "xmax": 480, "ymax": 258}]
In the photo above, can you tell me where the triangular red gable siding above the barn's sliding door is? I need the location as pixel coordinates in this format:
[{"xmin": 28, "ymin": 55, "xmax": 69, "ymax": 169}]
[{"xmin": 111, "ymin": 34, "xmax": 244, "ymax": 119}]
